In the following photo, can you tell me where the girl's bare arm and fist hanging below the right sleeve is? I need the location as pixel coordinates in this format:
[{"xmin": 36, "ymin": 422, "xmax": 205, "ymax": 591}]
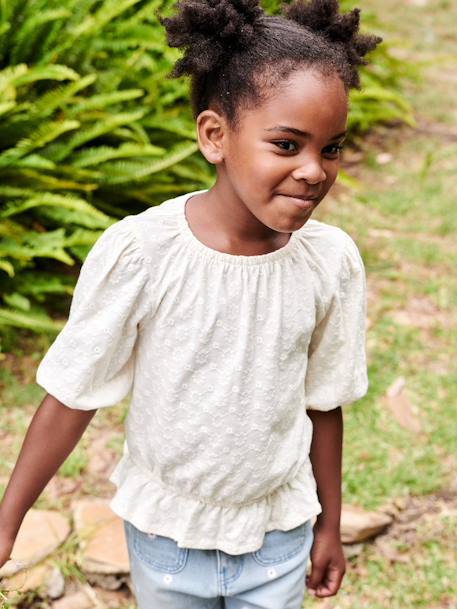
[{"xmin": 307, "ymin": 407, "xmax": 346, "ymax": 598}]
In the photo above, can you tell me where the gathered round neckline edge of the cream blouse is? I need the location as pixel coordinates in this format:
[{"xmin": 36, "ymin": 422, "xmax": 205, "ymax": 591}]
[{"xmin": 178, "ymin": 189, "xmax": 298, "ymax": 266}]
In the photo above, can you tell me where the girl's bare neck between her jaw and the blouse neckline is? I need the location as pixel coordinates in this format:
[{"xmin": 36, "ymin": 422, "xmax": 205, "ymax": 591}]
[{"xmin": 186, "ymin": 180, "xmax": 290, "ymax": 256}]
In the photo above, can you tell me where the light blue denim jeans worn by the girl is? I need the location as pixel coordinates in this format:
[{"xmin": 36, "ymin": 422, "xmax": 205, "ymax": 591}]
[{"xmin": 124, "ymin": 520, "xmax": 313, "ymax": 609}]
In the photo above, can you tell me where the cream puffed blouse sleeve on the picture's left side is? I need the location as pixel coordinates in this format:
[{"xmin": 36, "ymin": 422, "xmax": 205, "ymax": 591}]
[{"xmin": 36, "ymin": 220, "xmax": 149, "ymax": 410}]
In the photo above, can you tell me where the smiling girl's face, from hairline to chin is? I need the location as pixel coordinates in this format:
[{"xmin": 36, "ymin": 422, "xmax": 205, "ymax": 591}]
[{"xmin": 208, "ymin": 69, "xmax": 347, "ymax": 232}]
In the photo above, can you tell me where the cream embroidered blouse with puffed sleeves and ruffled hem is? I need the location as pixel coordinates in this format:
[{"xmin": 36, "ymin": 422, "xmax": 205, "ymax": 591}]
[{"xmin": 37, "ymin": 191, "xmax": 367, "ymax": 554}]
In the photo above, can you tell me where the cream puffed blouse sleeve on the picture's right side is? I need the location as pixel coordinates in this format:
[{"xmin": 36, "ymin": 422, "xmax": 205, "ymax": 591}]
[{"xmin": 305, "ymin": 235, "xmax": 368, "ymax": 411}]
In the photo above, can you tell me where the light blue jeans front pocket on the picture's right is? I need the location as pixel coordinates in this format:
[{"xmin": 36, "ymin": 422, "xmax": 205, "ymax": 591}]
[{"xmin": 253, "ymin": 521, "xmax": 311, "ymax": 567}]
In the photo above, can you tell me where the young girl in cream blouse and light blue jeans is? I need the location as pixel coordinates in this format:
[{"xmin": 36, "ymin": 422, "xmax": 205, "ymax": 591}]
[{"xmin": 0, "ymin": 0, "xmax": 380, "ymax": 609}]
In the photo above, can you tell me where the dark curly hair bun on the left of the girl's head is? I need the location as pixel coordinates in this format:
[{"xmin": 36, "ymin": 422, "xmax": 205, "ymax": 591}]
[{"xmin": 160, "ymin": 0, "xmax": 263, "ymax": 76}]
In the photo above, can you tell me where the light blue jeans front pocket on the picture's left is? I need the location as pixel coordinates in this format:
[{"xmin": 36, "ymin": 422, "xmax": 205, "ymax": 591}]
[{"xmin": 126, "ymin": 523, "xmax": 189, "ymax": 573}]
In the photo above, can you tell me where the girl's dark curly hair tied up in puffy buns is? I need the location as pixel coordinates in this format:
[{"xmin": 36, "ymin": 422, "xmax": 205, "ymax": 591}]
[{"xmin": 160, "ymin": 0, "xmax": 382, "ymax": 124}]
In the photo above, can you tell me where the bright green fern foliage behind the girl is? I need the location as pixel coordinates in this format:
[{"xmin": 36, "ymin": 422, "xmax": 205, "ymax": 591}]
[{"xmin": 0, "ymin": 0, "xmax": 411, "ymax": 333}]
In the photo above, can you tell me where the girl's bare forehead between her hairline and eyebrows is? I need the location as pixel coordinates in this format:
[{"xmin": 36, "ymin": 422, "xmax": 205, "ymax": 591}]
[{"xmin": 245, "ymin": 70, "xmax": 348, "ymax": 134}]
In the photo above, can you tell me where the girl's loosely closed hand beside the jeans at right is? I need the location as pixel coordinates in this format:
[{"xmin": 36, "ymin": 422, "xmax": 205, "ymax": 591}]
[{"xmin": 306, "ymin": 525, "xmax": 346, "ymax": 598}]
